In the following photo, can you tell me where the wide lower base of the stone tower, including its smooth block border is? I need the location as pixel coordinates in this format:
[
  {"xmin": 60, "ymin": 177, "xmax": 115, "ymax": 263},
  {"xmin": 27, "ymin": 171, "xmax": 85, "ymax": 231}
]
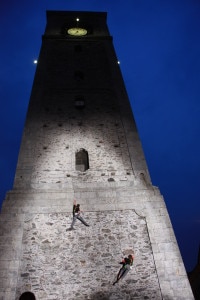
[{"xmin": 0, "ymin": 181, "xmax": 194, "ymax": 300}]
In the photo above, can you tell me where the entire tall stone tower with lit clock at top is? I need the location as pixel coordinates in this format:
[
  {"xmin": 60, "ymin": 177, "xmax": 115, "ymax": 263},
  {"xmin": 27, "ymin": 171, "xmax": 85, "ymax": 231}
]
[{"xmin": 0, "ymin": 11, "xmax": 193, "ymax": 300}]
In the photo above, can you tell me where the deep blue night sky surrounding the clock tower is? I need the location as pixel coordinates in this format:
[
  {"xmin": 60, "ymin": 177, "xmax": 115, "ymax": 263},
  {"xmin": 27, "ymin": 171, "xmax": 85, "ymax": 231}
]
[{"xmin": 0, "ymin": 0, "xmax": 200, "ymax": 271}]
